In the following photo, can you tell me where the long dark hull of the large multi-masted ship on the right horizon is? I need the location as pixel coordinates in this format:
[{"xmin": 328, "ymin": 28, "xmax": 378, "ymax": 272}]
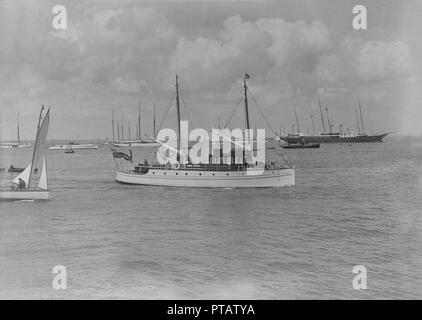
[{"xmin": 281, "ymin": 133, "xmax": 388, "ymax": 144}]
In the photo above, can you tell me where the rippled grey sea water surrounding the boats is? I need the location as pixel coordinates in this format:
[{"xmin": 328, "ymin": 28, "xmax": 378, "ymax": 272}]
[{"xmin": 0, "ymin": 138, "xmax": 422, "ymax": 299}]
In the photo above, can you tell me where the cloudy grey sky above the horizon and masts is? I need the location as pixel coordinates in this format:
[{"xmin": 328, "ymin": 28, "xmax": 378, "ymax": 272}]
[{"xmin": 0, "ymin": 0, "xmax": 422, "ymax": 141}]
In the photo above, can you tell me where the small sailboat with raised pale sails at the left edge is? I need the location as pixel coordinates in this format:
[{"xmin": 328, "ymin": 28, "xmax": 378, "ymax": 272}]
[{"xmin": 0, "ymin": 106, "xmax": 50, "ymax": 200}]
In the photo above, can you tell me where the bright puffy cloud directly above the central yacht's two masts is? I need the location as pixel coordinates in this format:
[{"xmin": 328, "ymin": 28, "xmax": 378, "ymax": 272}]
[{"xmin": 169, "ymin": 15, "xmax": 331, "ymax": 95}]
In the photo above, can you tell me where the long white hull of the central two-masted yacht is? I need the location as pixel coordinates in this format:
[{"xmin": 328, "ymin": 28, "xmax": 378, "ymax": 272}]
[{"xmin": 116, "ymin": 168, "xmax": 295, "ymax": 188}]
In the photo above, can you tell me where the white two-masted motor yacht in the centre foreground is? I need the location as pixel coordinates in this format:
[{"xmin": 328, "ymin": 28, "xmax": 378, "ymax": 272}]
[{"xmin": 110, "ymin": 74, "xmax": 295, "ymax": 188}]
